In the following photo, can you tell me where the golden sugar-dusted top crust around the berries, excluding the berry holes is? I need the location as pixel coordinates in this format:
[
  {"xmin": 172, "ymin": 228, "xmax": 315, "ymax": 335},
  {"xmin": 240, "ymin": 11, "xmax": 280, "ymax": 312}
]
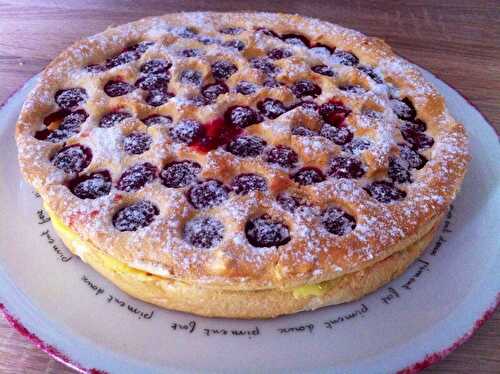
[{"xmin": 16, "ymin": 13, "xmax": 469, "ymax": 292}]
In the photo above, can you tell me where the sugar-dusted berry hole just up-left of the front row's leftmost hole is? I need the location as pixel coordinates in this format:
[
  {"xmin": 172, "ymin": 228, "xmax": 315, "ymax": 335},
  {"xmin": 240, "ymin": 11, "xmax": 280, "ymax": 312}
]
[{"xmin": 68, "ymin": 170, "xmax": 111, "ymax": 199}]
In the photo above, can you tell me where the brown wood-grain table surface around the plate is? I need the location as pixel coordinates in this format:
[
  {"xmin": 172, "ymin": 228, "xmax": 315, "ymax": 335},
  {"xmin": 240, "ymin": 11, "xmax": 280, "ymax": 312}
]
[{"xmin": 0, "ymin": 0, "xmax": 500, "ymax": 373}]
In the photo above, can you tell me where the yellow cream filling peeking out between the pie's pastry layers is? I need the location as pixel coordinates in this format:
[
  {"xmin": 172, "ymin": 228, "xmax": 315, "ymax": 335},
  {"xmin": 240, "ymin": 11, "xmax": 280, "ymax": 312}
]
[{"xmin": 44, "ymin": 204, "xmax": 339, "ymax": 299}]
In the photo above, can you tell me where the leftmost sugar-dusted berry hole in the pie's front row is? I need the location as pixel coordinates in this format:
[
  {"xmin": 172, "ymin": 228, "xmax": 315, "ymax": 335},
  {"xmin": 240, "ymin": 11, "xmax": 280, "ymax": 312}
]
[{"xmin": 113, "ymin": 200, "xmax": 160, "ymax": 231}]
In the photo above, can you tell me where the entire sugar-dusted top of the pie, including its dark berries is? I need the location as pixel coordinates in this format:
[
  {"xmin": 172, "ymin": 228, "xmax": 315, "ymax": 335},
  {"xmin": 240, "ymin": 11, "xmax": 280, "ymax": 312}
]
[{"xmin": 16, "ymin": 12, "xmax": 469, "ymax": 290}]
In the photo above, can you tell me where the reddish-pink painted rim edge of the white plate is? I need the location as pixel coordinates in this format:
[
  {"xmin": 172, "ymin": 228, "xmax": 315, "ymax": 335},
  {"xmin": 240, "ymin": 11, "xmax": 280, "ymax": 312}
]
[{"xmin": 0, "ymin": 71, "xmax": 500, "ymax": 374}]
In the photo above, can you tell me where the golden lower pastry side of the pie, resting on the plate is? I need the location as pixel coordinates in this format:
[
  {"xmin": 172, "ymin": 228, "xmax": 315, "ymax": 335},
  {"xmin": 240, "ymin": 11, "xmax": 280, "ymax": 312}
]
[{"xmin": 55, "ymin": 206, "xmax": 442, "ymax": 319}]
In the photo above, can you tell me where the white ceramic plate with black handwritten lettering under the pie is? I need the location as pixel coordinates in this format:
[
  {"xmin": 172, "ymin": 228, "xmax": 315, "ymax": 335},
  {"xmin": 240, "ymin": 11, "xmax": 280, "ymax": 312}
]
[{"xmin": 0, "ymin": 69, "xmax": 500, "ymax": 373}]
